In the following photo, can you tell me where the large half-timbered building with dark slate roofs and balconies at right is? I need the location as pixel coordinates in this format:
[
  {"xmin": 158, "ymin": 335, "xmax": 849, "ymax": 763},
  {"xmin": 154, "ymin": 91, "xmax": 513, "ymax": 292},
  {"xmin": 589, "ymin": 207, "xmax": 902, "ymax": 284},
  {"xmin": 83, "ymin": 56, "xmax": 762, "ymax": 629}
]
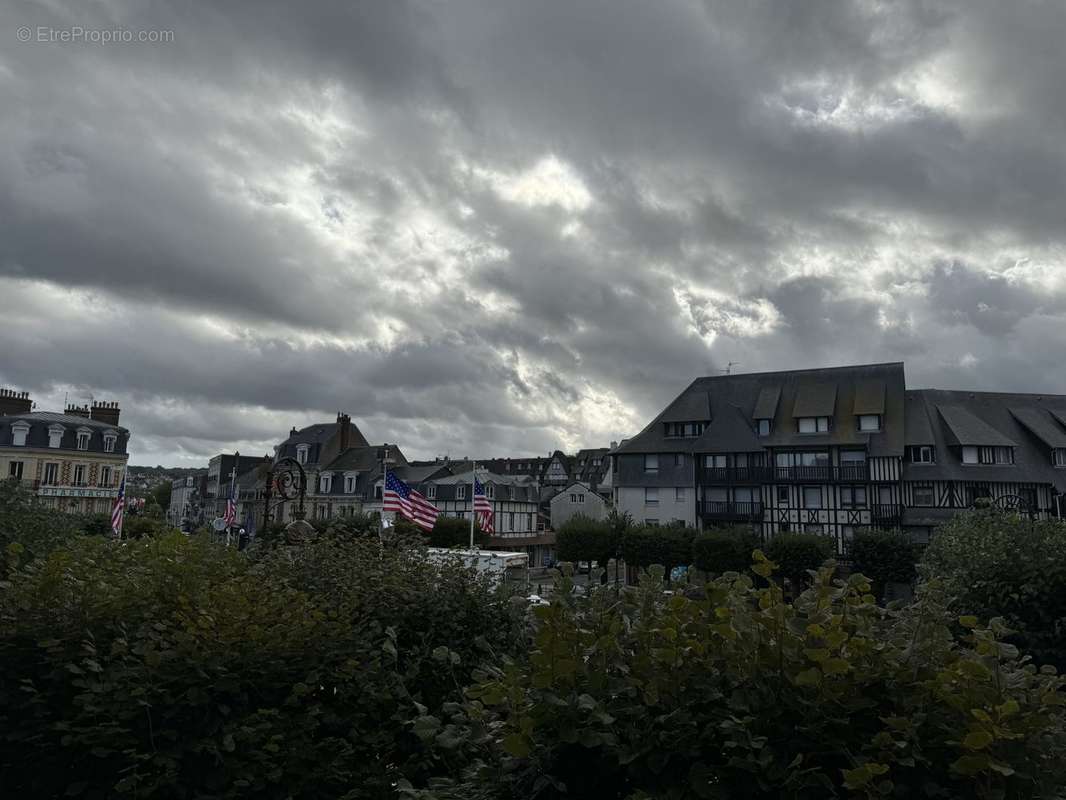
[{"xmin": 612, "ymin": 363, "xmax": 1066, "ymax": 546}]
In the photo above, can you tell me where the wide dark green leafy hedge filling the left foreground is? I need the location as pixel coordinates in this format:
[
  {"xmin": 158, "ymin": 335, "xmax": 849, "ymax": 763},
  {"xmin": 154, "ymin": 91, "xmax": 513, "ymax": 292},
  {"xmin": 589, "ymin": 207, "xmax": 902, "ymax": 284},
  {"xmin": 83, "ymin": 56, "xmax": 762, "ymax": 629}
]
[{"xmin": 0, "ymin": 533, "xmax": 521, "ymax": 798}]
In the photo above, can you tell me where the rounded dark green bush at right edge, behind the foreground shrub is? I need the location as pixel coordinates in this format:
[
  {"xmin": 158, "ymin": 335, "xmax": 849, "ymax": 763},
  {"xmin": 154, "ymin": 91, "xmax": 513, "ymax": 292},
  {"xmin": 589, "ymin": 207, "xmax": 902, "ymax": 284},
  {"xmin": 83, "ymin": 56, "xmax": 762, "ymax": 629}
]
[{"xmin": 921, "ymin": 510, "xmax": 1066, "ymax": 669}]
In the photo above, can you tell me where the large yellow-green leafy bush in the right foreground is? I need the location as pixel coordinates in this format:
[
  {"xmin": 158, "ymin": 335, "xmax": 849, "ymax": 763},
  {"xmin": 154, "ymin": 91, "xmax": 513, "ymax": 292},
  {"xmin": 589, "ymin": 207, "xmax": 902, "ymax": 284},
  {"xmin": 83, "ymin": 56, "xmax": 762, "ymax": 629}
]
[{"xmin": 424, "ymin": 551, "xmax": 1066, "ymax": 800}]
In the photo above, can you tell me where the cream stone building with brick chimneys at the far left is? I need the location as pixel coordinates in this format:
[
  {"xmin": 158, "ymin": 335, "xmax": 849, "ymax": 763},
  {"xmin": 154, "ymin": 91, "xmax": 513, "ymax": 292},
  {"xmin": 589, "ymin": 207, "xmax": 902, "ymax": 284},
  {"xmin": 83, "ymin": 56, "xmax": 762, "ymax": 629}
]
[{"xmin": 0, "ymin": 388, "xmax": 130, "ymax": 514}]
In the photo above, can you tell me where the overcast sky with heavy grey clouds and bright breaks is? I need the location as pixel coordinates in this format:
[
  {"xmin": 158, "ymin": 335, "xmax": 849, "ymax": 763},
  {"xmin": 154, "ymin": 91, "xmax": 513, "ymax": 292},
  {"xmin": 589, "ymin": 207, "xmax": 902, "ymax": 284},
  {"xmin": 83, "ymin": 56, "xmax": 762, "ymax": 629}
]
[{"xmin": 0, "ymin": 0, "xmax": 1066, "ymax": 466}]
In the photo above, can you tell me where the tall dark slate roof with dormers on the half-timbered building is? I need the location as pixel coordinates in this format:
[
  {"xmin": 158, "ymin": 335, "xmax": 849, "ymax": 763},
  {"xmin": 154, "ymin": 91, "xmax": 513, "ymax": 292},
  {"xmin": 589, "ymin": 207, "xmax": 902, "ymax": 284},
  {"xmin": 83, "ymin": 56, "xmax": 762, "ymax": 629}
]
[{"xmin": 616, "ymin": 362, "xmax": 905, "ymax": 457}]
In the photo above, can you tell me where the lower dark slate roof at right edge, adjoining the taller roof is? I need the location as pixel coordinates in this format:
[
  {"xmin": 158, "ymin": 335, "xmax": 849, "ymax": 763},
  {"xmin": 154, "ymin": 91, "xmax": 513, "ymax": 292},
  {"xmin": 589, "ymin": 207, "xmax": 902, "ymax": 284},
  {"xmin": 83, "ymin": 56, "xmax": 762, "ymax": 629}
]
[{"xmin": 903, "ymin": 389, "xmax": 1066, "ymax": 491}]
